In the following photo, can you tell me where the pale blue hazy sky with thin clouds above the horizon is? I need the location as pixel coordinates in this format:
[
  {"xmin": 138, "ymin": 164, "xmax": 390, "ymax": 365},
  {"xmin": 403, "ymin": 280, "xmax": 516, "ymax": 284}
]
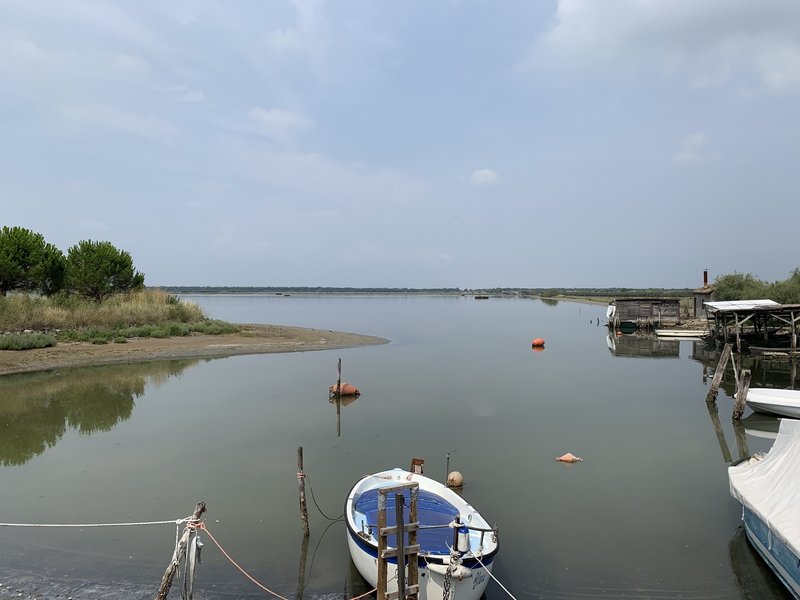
[{"xmin": 0, "ymin": 0, "xmax": 800, "ymax": 289}]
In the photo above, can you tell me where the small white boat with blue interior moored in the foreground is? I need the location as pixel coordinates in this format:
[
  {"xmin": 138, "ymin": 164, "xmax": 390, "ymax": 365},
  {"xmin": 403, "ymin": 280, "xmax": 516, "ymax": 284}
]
[{"xmin": 345, "ymin": 469, "xmax": 498, "ymax": 600}]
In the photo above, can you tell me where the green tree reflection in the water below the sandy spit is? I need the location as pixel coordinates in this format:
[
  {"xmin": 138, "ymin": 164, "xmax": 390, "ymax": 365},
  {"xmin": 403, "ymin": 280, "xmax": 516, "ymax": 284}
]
[{"xmin": 0, "ymin": 360, "xmax": 198, "ymax": 466}]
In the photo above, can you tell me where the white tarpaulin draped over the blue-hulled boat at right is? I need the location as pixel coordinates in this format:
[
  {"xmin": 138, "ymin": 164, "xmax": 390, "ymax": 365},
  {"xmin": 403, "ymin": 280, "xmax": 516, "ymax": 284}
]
[{"xmin": 728, "ymin": 419, "xmax": 800, "ymax": 555}]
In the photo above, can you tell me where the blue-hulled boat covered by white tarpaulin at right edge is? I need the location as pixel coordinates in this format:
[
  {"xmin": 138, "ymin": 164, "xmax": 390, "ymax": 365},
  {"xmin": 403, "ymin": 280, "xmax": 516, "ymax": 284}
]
[{"xmin": 728, "ymin": 419, "xmax": 800, "ymax": 598}]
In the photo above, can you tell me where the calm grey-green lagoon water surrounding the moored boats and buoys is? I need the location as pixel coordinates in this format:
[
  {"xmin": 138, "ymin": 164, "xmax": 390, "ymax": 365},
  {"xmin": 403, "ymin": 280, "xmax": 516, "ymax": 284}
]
[{"xmin": 0, "ymin": 296, "xmax": 791, "ymax": 600}]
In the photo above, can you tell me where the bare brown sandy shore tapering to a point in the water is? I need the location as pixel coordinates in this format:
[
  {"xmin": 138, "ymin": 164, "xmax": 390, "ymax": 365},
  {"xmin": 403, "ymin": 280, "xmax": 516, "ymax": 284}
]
[{"xmin": 0, "ymin": 325, "xmax": 389, "ymax": 375}]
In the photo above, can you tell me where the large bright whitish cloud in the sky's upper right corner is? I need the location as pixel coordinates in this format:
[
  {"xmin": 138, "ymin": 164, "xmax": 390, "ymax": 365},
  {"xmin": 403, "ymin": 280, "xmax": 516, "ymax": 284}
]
[{"xmin": 520, "ymin": 0, "xmax": 800, "ymax": 91}]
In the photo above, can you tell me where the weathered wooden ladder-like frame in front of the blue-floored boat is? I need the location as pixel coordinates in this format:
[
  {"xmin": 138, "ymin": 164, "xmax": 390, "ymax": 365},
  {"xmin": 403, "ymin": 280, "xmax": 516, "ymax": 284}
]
[{"xmin": 377, "ymin": 482, "xmax": 419, "ymax": 600}]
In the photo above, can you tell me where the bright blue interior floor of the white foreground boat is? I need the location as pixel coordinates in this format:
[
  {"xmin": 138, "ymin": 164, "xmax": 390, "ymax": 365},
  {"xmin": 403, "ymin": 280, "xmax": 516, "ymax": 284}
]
[{"xmin": 353, "ymin": 489, "xmax": 458, "ymax": 556}]
